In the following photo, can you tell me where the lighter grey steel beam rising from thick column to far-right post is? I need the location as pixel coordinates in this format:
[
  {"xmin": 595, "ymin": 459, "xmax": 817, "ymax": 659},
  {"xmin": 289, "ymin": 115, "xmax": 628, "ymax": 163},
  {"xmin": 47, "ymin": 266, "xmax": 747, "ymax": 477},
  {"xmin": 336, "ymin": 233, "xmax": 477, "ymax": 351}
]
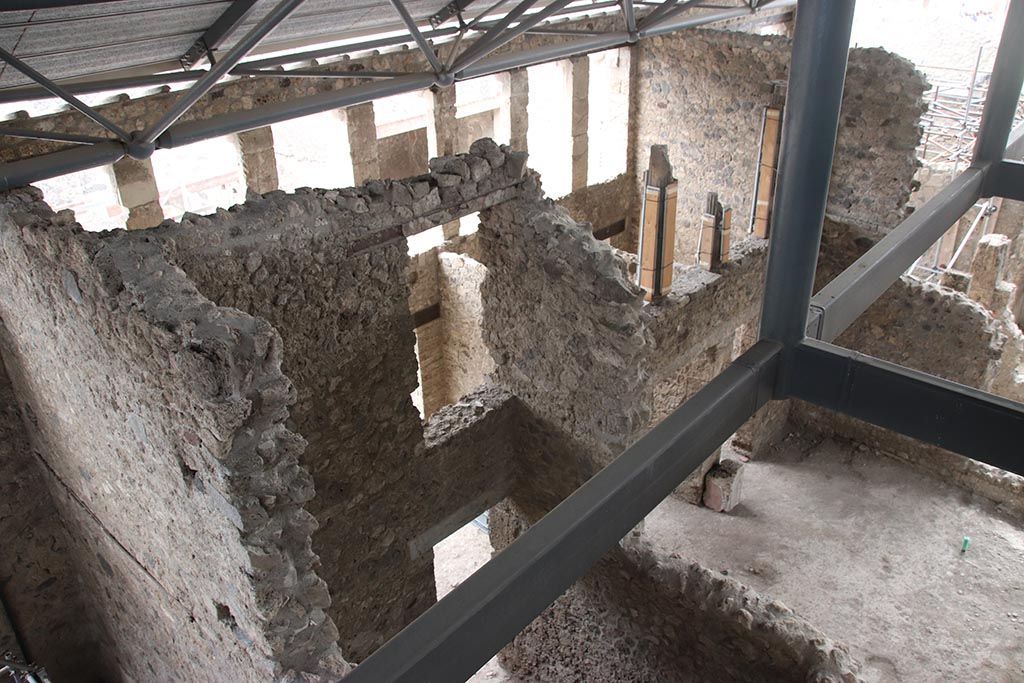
[{"xmin": 806, "ymin": 167, "xmax": 985, "ymax": 341}]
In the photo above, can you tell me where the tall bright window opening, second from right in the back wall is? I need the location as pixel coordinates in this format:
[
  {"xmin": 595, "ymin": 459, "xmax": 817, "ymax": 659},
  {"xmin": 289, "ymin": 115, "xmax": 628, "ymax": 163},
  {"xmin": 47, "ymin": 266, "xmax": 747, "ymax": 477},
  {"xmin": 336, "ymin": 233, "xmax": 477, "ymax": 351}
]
[{"xmin": 526, "ymin": 59, "xmax": 572, "ymax": 198}]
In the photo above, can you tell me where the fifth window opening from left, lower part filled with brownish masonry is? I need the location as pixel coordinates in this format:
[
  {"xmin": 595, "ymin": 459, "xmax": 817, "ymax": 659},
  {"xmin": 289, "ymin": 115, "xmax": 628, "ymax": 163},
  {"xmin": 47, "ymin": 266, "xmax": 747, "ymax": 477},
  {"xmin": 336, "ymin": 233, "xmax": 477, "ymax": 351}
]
[{"xmin": 455, "ymin": 74, "xmax": 512, "ymax": 147}]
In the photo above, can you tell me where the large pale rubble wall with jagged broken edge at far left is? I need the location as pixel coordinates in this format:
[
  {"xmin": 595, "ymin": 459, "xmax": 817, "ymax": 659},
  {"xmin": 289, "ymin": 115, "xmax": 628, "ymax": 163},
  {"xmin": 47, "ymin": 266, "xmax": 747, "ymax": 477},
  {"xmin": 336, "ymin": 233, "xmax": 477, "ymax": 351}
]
[{"xmin": 0, "ymin": 189, "xmax": 347, "ymax": 682}]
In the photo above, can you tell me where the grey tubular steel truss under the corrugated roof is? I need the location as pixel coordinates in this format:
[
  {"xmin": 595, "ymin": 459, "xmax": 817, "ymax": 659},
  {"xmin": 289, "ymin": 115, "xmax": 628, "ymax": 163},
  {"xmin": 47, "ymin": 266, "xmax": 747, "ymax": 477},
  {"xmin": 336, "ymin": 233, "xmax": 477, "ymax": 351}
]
[{"xmin": 0, "ymin": 0, "xmax": 797, "ymax": 190}]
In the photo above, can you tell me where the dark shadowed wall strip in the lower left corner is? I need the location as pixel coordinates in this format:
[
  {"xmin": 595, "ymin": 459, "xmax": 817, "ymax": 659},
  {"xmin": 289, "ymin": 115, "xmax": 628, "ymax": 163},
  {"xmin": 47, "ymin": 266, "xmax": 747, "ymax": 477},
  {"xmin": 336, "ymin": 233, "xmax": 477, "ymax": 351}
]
[{"xmin": 0, "ymin": 350, "xmax": 107, "ymax": 683}]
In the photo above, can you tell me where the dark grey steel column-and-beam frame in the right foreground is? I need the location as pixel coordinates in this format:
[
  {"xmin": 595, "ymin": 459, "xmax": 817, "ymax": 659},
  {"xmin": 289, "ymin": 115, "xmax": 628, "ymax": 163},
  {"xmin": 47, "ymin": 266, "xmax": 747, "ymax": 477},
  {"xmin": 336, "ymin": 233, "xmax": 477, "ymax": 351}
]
[{"xmin": 337, "ymin": 0, "xmax": 1024, "ymax": 683}]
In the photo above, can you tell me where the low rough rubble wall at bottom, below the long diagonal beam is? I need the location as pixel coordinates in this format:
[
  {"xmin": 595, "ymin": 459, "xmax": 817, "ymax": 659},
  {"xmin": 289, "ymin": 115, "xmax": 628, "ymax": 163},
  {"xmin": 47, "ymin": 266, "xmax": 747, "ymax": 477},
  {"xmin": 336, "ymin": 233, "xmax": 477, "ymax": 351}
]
[{"xmin": 489, "ymin": 504, "xmax": 861, "ymax": 683}]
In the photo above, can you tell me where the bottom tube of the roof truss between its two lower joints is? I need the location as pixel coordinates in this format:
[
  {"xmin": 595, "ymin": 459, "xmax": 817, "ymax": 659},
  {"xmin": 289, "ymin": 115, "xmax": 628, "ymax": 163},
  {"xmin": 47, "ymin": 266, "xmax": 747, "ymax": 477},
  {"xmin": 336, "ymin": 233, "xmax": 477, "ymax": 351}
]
[{"xmin": 157, "ymin": 73, "xmax": 436, "ymax": 148}]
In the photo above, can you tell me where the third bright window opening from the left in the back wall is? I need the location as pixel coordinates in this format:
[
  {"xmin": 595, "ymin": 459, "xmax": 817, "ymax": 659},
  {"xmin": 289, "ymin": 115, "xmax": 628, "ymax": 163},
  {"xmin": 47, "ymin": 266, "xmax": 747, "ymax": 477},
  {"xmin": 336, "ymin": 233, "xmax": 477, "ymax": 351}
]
[{"xmin": 270, "ymin": 110, "xmax": 355, "ymax": 193}]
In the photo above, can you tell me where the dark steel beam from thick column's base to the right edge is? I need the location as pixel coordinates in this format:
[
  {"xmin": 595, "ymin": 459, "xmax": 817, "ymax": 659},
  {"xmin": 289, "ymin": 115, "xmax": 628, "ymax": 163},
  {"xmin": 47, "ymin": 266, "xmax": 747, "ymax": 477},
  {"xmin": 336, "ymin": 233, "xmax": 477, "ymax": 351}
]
[{"xmin": 790, "ymin": 340, "xmax": 1024, "ymax": 474}]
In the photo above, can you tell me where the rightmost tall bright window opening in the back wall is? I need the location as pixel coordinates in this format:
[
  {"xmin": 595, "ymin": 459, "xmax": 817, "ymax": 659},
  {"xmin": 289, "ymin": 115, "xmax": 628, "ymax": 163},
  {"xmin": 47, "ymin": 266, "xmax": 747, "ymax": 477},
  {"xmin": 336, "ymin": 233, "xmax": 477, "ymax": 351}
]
[{"xmin": 587, "ymin": 48, "xmax": 630, "ymax": 185}]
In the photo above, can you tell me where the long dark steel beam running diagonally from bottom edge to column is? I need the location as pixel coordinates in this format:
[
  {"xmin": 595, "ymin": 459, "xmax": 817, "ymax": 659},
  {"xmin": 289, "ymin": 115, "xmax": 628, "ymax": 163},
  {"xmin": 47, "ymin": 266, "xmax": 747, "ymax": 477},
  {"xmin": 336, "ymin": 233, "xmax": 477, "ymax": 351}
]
[{"xmin": 344, "ymin": 341, "xmax": 781, "ymax": 683}]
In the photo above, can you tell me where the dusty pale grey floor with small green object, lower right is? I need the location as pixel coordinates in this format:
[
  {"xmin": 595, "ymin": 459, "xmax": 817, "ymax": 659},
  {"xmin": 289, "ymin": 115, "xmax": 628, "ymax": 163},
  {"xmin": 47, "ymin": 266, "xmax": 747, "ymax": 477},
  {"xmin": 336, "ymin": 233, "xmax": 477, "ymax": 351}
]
[{"xmin": 646, "ymin": 435, "xmax": 1024, "ymax": 683}]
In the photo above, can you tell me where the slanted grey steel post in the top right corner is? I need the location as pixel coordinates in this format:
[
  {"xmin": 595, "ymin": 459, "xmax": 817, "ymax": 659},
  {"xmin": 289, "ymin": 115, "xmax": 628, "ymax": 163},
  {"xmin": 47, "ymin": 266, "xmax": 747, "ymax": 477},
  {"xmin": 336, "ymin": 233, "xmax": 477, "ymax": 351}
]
[{"xmin": 973, "ymin": 0, "xmax": 1024, "ymax": 164}]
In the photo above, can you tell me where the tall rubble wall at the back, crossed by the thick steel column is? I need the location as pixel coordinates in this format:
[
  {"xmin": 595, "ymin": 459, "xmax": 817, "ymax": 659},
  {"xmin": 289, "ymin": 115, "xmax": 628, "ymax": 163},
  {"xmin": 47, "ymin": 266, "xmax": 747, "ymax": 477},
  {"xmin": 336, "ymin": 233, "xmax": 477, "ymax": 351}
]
[{"xmin": 630, "ymin": 30, "xmax": 924, "ymax": 263}]
